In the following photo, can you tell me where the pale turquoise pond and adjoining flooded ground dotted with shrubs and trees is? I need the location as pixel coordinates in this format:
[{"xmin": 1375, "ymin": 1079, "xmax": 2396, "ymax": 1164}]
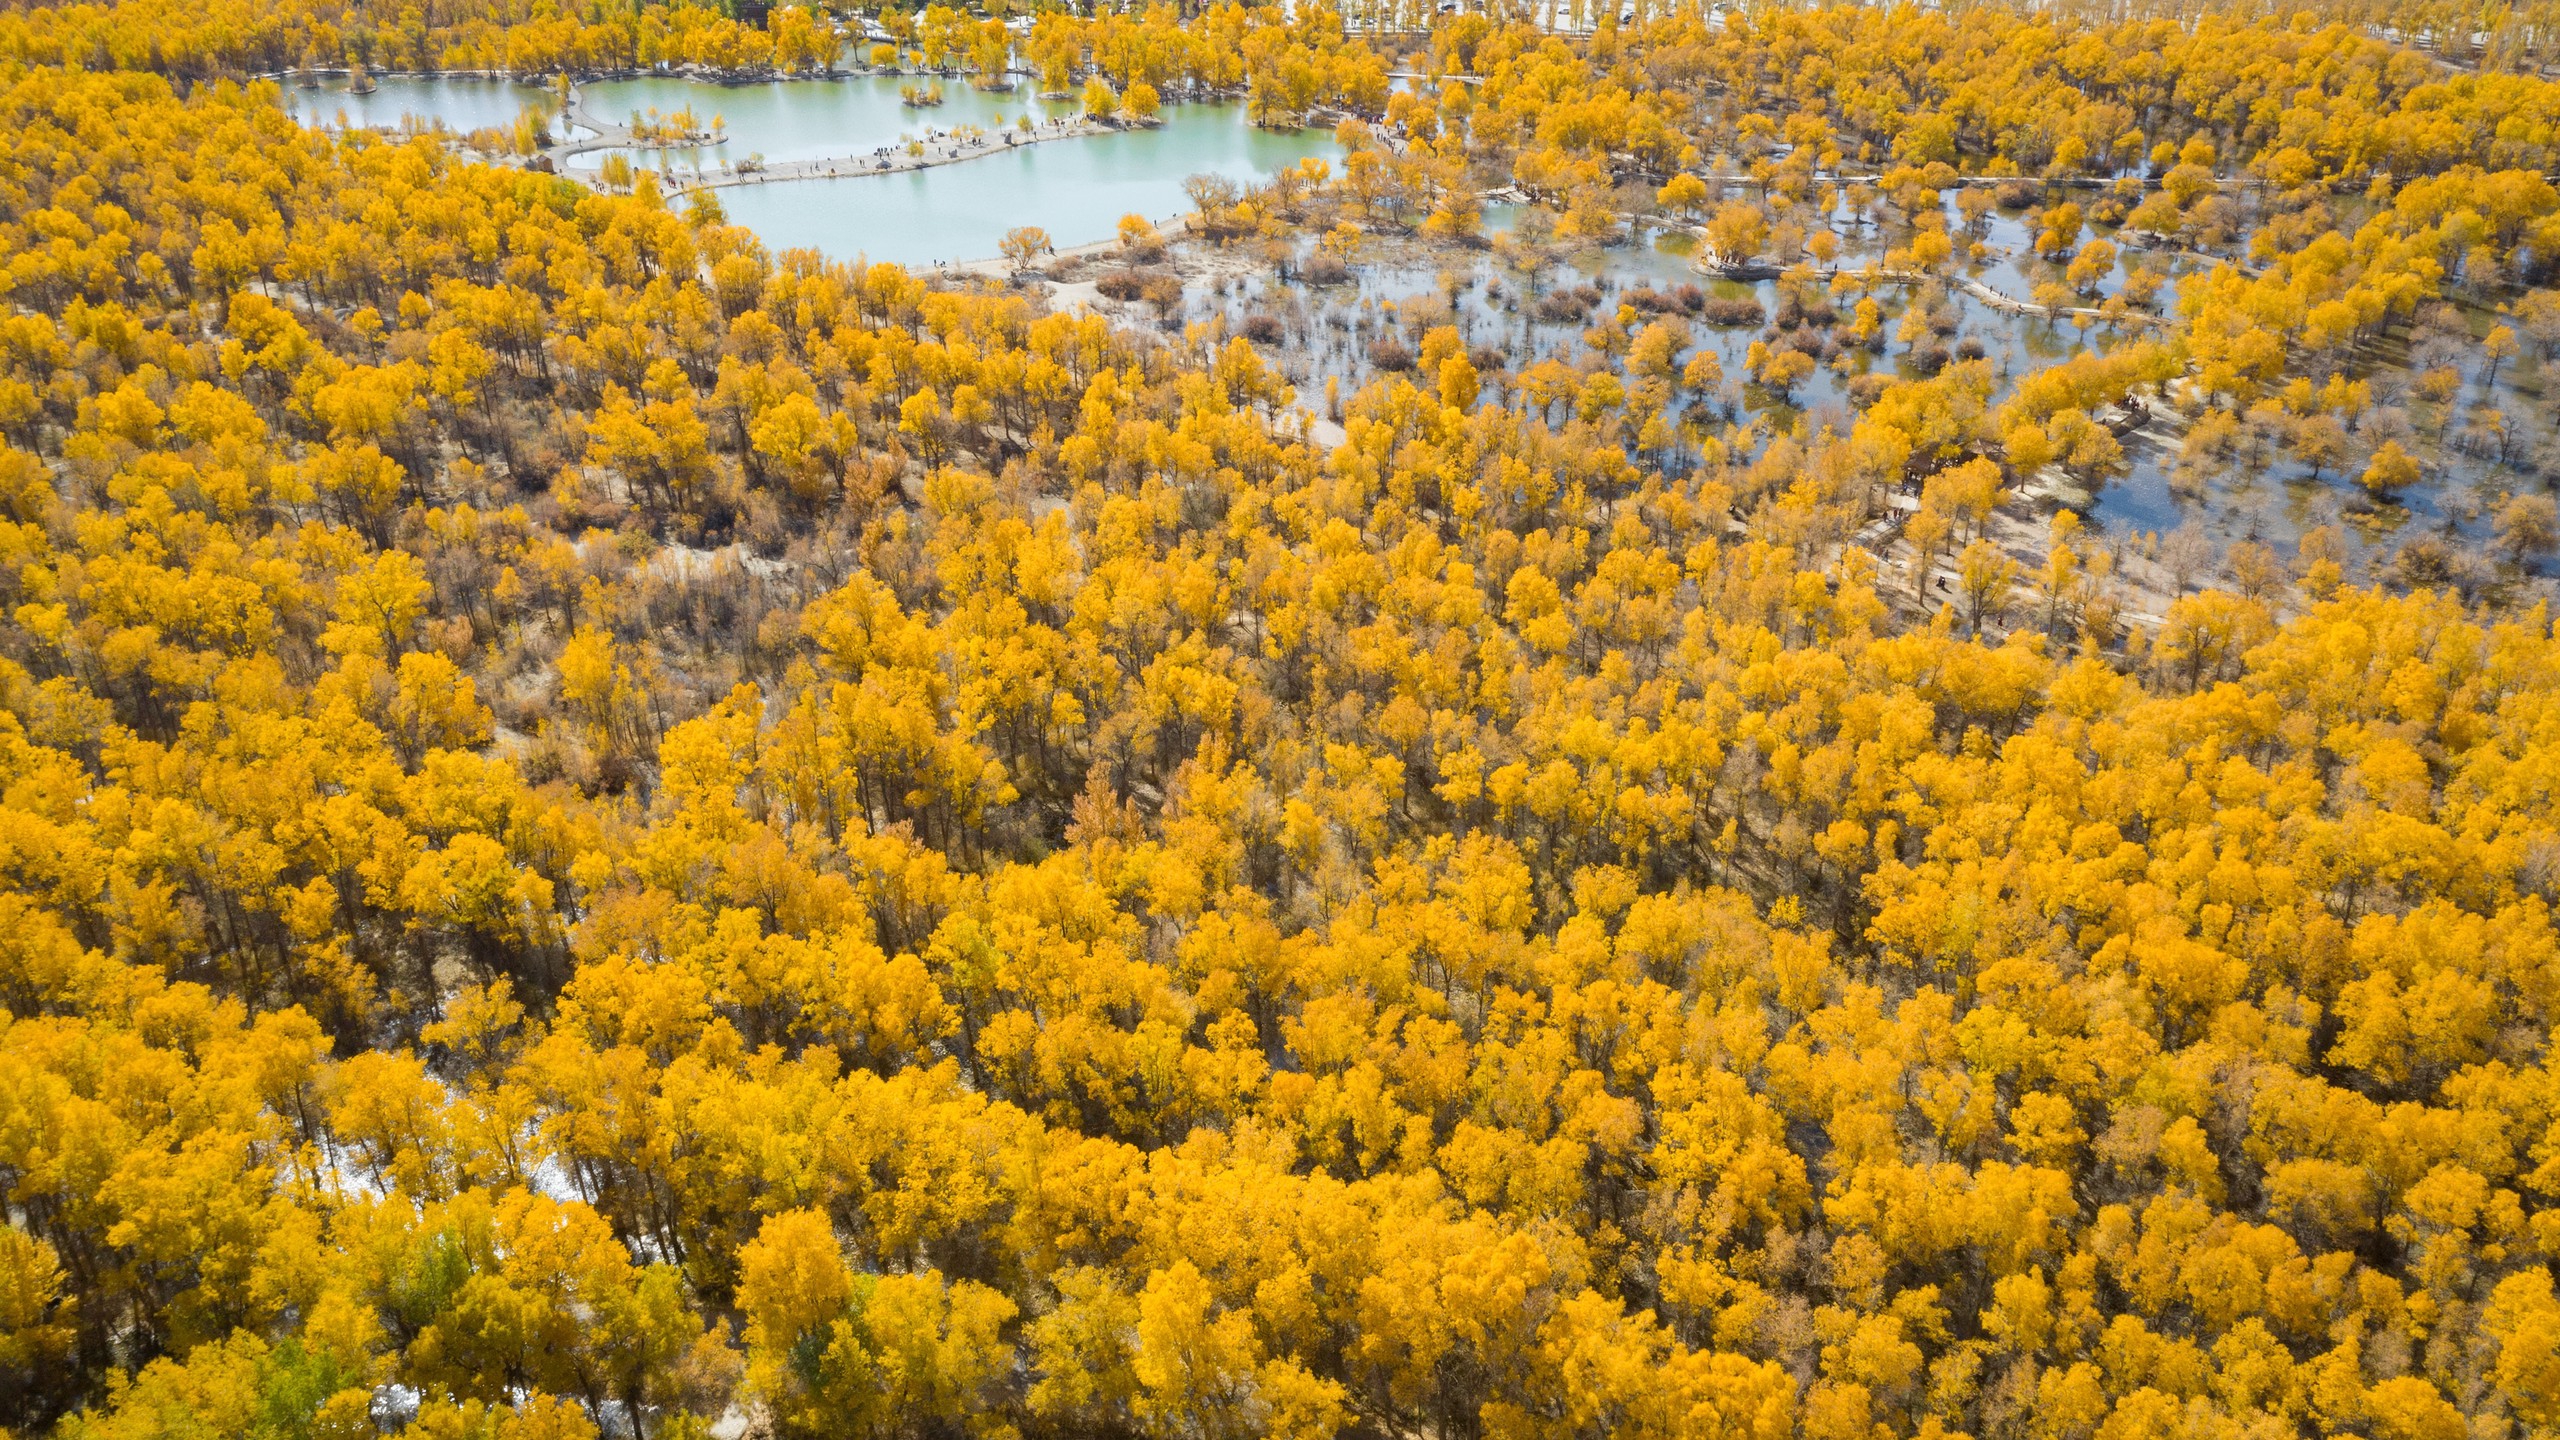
[{"xmin": 287, "ymin": 51, "xmax": 2560, "ymax": 620}]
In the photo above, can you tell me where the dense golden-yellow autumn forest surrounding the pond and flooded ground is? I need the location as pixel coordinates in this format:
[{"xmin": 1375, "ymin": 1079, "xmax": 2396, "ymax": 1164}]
[{"xmin": 0, "ymin": 0, "xmax": 2560, "ymax": 1440}]
